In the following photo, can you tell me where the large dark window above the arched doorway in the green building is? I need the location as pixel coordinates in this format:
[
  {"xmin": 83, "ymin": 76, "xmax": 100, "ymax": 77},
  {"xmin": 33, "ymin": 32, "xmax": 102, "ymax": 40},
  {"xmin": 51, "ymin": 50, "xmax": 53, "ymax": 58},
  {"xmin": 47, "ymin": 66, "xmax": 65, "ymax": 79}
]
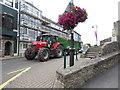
[{"xmin": 2, "ymin": 14, "xmax": 14, "ymax": 29}]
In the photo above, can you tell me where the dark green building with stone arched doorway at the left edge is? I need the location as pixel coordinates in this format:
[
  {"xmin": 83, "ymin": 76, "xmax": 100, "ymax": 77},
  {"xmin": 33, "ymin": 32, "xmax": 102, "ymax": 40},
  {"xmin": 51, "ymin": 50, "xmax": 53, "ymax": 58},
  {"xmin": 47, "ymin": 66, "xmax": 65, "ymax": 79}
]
[{"xmin": 0, "ymin": 0, "xmax": 18, "ymax": 57}]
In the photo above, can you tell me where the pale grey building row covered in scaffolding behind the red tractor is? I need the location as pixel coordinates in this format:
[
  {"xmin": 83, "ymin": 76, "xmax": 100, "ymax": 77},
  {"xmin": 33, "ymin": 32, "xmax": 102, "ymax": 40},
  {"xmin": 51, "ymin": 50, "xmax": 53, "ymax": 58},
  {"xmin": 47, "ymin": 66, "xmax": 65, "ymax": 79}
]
[{"xmin": 18, "ymin": 0, "xmax": 69, "ymax": 56}]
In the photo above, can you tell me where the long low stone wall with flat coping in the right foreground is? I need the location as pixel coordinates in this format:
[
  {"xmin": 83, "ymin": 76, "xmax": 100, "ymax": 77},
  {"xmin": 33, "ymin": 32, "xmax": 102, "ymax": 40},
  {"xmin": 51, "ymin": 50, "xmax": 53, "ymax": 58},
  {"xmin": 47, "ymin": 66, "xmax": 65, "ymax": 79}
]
[{"xmin": 55, "ymin": 53, "xmax": 120, "ymax": 88}]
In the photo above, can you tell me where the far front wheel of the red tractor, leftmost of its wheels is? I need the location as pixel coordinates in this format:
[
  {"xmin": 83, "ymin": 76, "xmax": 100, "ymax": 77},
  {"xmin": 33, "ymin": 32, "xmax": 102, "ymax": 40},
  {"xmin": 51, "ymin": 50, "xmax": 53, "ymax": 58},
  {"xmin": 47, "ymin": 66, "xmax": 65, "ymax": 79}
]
[{"xmin": 25, "ymin": 48, "xmax": 36, "ymax": 60}]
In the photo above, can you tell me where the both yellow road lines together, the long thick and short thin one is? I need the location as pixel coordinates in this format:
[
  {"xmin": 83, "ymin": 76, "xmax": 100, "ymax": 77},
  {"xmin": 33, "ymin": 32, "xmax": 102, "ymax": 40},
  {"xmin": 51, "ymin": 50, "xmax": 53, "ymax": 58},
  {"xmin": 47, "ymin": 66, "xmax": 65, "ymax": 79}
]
[{"xmin": 0, "ymin": 67, "xmax": 31, "ymax": 90}]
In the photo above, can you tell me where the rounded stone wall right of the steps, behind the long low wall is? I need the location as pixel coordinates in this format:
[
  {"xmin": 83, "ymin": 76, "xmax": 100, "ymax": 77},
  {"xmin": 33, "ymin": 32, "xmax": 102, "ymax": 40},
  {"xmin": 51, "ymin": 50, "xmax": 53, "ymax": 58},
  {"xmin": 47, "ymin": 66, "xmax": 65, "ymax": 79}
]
[{"xmin": 101, "ymin": 42, "xmax": 120, "ymax": 56}]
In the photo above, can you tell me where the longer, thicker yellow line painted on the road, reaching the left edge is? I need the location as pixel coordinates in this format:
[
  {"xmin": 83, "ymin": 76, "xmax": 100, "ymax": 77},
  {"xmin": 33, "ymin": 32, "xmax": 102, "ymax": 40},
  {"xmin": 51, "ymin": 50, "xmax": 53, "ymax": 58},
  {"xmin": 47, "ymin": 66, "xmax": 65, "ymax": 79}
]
[{"xmin": 0, "ymin": 67, "xmax": 31, "ymax": 90}]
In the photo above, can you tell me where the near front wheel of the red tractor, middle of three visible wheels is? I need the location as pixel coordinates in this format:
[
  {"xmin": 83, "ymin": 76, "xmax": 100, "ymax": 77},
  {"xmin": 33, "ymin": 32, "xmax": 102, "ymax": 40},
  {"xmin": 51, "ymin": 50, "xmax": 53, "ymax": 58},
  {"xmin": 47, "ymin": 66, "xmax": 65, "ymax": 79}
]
[{"xmin": 37, "ymin": 48, "xmax": 50, "ymax": 62}]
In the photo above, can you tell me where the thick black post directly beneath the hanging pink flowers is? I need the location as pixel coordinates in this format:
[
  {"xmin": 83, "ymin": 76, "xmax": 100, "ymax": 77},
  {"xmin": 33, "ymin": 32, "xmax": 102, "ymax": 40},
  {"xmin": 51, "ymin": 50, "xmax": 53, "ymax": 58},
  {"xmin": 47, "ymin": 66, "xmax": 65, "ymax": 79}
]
[{"xmin": 70, "ymin": 30, "xmax": 74, "ymax": 67}]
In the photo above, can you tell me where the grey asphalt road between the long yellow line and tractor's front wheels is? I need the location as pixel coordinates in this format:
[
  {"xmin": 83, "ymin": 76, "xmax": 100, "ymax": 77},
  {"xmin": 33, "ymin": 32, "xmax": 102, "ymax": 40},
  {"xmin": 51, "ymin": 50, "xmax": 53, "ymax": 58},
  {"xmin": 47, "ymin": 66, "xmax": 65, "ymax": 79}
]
[{"xmin": 2, "ymin": 58, "xmax": 41, "ymax": 83}]
